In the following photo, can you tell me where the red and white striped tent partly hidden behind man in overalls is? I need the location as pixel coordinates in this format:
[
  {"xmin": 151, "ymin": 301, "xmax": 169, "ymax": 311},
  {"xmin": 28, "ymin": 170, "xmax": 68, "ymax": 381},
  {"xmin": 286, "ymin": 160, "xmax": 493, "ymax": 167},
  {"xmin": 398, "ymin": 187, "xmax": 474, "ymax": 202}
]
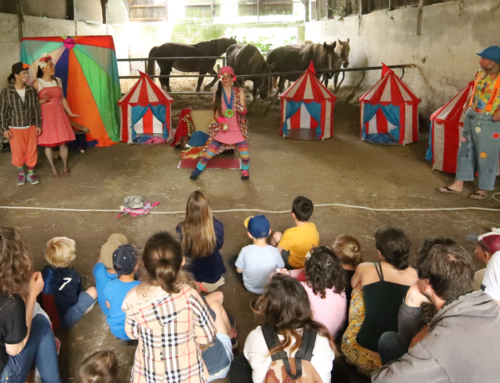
[{"xmin": 426, "ymin": 81, "xmax": 474, "ymax": 173}]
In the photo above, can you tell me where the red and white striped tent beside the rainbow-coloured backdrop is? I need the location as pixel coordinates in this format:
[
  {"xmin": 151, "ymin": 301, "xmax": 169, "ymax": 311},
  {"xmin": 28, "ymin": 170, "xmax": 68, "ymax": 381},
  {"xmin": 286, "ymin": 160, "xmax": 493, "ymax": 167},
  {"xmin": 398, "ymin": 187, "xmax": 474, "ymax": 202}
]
[{"xmin": 118, "ymin": 71, "xmax": 174, "ymax": 144}]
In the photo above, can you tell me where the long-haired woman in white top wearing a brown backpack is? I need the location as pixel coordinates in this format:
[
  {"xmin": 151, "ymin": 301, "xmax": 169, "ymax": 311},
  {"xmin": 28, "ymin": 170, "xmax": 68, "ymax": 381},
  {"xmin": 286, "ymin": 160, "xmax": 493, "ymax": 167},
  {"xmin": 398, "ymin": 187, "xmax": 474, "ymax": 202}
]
[{"xmin": 229, "ymin": 274, "xmax": 335, "ymax": 383}]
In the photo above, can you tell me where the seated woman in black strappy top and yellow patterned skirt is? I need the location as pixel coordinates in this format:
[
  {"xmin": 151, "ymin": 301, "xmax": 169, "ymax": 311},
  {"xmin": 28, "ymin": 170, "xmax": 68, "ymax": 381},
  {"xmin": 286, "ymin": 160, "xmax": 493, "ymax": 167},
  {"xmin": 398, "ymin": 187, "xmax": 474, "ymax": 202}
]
[{"xmin": 342, "ymin": 227, "xmax": 418, "ymax": 375}]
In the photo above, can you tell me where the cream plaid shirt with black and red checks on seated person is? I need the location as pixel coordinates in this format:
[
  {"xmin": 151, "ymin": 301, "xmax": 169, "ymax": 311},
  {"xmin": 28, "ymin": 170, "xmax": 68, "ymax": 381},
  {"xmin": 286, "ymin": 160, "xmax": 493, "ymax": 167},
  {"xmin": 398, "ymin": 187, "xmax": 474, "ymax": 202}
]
[{"xmin": 122, "ymin": 283, "xmax": 216, "ymax": 383}]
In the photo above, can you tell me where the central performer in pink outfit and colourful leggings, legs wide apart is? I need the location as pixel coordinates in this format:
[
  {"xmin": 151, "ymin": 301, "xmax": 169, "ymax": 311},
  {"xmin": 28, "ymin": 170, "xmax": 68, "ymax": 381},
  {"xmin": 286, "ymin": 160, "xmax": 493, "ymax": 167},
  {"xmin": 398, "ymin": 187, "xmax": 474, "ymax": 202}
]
[{"xmin": 190, "ymin": 66, "xmax": 250, "ymax": 181}]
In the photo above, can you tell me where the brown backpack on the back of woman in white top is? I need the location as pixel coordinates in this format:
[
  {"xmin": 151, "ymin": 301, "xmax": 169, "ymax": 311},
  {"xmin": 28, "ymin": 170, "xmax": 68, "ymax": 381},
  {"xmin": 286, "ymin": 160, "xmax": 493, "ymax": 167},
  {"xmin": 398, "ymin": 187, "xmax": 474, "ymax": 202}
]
[{"xmin": 262, "ymin": 325, "xmax": 323, "ymax": 383}]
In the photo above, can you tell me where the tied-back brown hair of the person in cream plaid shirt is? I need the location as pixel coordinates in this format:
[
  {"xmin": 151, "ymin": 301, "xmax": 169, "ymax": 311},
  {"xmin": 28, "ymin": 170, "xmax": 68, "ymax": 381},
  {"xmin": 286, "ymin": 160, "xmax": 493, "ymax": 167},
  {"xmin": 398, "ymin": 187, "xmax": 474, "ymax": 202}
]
[{"xmin": 142, "ymin": 231, "xmax": 184, "ymax": 293}]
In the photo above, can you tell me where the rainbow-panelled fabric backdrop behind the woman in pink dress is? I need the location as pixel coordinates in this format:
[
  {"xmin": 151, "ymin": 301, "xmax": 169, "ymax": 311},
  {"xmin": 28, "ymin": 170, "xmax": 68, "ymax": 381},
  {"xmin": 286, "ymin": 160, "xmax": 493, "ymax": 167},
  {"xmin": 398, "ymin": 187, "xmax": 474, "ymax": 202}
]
[{"xmin": 21, "ymin": 36, "xmax": 121, "ymax": 146}]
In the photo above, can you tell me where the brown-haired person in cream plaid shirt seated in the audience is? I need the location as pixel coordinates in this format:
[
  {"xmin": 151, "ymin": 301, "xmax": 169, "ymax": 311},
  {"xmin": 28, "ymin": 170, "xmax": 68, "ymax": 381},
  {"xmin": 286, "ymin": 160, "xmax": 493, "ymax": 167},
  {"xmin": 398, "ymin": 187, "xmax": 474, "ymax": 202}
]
[{"xmin": 122, "ymin": 232, "xmax": 216, "ymax": 383}]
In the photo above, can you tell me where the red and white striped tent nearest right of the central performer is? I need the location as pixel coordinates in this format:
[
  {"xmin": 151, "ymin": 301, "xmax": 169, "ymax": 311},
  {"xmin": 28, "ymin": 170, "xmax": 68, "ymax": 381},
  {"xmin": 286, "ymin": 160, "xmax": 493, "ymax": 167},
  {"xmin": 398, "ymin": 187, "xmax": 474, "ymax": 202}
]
[{"xmin": 280, "ymin": 61, "xmax": 337, "ymax": 140}]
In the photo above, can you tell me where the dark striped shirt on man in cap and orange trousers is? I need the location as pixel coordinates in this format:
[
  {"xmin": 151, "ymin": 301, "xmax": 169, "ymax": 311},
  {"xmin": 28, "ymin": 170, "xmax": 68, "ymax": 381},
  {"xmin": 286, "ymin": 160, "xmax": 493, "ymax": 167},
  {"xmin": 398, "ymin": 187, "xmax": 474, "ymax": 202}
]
[{"xmin": 0, "ymin": 85, "xmax": 42, "ymax": 131}]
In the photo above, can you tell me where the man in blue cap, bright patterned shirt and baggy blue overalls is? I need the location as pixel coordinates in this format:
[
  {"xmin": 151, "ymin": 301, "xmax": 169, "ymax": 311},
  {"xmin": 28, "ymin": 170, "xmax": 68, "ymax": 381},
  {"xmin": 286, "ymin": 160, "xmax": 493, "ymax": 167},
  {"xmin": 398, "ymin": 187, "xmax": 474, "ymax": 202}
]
[{"xmin": 437, "ymin": 46, "xmax": 500, "ymax": 200}]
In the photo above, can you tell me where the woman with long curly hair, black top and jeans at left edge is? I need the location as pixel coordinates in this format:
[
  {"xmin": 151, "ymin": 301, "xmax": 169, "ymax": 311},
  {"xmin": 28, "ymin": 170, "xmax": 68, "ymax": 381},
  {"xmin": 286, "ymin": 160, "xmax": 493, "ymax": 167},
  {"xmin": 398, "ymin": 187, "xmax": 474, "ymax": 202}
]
[{"xmin": 0, "ymin": 227, "xmax": 61, "ymax": 383}]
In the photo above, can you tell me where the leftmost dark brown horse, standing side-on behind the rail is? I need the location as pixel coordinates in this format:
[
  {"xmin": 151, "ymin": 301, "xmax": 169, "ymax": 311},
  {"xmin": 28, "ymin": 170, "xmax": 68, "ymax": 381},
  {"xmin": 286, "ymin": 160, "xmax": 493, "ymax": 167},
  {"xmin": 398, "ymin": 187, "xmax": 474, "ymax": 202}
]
[{"xmin": 148, "ymin": 37, "xmax": 237, "ymax": 92}]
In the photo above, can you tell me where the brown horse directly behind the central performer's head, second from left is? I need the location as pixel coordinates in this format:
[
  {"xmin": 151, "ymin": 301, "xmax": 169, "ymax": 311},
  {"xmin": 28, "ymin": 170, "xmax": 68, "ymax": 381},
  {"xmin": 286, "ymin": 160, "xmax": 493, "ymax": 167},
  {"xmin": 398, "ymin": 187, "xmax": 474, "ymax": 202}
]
[{"xmin": 226, "ymin": 44, "xmax": 274, "ymax": 108}]
